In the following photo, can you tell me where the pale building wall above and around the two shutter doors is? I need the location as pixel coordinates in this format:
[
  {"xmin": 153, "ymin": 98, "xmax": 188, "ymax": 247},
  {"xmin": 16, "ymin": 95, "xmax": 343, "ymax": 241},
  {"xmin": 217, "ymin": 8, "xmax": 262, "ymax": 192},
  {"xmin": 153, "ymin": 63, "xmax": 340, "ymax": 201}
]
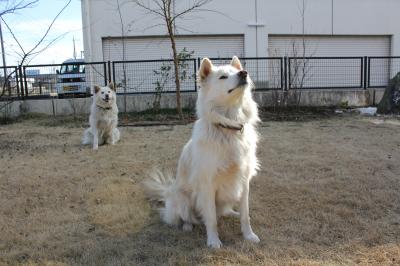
[{"xmin": 82, "ymin": 0, "xmax": 400, "ymax": 61}]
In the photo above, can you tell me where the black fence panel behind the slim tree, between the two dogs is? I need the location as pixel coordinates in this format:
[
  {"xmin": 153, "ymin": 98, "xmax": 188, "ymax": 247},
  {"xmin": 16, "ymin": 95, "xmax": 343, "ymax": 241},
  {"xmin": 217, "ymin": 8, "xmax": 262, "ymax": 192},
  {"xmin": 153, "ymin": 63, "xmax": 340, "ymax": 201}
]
[{"xmin": 112, "ymin": 59, "xmax": 197, "ymax": 94}]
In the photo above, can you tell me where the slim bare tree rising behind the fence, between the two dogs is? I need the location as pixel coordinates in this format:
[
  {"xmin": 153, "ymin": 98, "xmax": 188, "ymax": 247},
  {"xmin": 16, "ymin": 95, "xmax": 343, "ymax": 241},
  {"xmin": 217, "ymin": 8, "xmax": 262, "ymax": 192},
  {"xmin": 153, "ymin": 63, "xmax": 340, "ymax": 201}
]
[{"xmin": 133, "ymin": 0, "xmax": 212, "ymax": 119}]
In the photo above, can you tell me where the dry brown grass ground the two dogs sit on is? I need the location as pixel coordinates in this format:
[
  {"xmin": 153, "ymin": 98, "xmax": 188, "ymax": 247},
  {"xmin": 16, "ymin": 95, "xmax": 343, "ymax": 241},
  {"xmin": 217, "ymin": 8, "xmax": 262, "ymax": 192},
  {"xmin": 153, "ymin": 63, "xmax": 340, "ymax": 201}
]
[{"xmin": 0, "ymin": 115, "xmax": 400, "ymax": 265}]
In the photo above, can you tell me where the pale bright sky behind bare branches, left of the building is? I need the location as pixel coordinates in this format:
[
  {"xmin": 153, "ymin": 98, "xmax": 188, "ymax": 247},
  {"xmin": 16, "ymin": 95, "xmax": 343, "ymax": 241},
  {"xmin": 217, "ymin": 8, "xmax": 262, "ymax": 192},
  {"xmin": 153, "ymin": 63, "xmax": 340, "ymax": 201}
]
[{"xmin": 0, "ymin": 0, "xmax": 83, "ymax": 65}]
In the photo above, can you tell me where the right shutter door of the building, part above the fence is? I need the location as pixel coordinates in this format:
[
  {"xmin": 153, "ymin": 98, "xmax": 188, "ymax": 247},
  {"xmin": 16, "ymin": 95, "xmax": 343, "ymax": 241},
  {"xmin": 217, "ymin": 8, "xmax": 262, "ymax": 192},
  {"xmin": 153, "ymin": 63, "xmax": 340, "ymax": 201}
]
[{"xmin": 268, "ymin": 35, "xmax": 390, "ymax": 57}]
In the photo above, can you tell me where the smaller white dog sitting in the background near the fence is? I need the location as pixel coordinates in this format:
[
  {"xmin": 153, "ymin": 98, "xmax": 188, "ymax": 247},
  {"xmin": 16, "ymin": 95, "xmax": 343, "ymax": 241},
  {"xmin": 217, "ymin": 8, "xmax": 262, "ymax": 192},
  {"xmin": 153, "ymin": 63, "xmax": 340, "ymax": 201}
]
[{"xmin": 82, "ymin": 83, "xmax": 120, "ymax": 150}]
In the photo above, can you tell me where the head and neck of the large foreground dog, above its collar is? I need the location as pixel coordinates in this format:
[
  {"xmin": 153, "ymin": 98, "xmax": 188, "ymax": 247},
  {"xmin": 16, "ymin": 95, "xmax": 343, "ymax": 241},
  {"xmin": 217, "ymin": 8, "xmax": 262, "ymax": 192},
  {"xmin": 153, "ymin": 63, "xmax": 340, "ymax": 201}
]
[{"xmin": 196, "ymin": 56, "xmax": 259, "ymax": 127}]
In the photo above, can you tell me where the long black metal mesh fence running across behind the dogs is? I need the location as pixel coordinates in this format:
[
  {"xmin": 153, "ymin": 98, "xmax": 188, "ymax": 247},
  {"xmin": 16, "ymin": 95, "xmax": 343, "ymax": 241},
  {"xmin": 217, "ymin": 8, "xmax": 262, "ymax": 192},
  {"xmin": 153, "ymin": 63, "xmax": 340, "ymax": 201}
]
[{"xmin": 0, "ymin": 57, "xmax": 400, "ymax": 100}]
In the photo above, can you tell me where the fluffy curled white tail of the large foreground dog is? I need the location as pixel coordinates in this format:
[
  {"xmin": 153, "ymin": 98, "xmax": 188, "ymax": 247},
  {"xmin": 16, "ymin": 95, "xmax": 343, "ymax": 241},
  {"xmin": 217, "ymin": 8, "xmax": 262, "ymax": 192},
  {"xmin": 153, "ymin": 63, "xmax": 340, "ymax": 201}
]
[{"xmin": 143, "ymin": 169, "xmax": 175, "ymax": 202}]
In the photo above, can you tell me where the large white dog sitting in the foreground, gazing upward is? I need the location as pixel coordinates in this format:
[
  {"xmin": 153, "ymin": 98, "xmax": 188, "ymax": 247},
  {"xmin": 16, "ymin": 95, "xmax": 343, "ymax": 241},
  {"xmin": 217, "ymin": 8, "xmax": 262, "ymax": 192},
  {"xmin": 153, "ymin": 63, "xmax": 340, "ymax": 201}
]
[{"xmin": 145, "ymin": 56, "xmax": 260, "ymax": 248}]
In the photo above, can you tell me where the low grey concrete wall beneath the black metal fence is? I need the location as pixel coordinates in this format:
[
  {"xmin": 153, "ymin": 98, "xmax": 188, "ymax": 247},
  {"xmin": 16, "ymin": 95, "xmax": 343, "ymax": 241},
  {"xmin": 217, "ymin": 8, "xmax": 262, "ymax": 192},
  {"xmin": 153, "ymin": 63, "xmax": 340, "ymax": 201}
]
[{"xmin": 0, "ymin": 89, "xmax": 384, "ymax": 117}]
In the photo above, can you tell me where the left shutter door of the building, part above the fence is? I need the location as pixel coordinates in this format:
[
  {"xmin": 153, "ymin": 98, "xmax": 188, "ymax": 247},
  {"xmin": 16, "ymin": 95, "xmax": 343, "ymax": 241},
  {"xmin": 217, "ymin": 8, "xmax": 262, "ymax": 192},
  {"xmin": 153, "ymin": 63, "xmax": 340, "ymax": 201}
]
[{"xmin": 103, "ymin": 35, "xmax": 244, "ymax": 61}]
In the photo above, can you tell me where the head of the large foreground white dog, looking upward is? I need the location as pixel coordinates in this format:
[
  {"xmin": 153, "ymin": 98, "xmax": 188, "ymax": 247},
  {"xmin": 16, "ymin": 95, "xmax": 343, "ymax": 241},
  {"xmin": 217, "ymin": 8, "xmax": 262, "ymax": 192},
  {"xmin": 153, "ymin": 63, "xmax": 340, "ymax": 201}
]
[{"xmin": 198, "ymin": 56, "xmax": 253, "ymax": 106}]
